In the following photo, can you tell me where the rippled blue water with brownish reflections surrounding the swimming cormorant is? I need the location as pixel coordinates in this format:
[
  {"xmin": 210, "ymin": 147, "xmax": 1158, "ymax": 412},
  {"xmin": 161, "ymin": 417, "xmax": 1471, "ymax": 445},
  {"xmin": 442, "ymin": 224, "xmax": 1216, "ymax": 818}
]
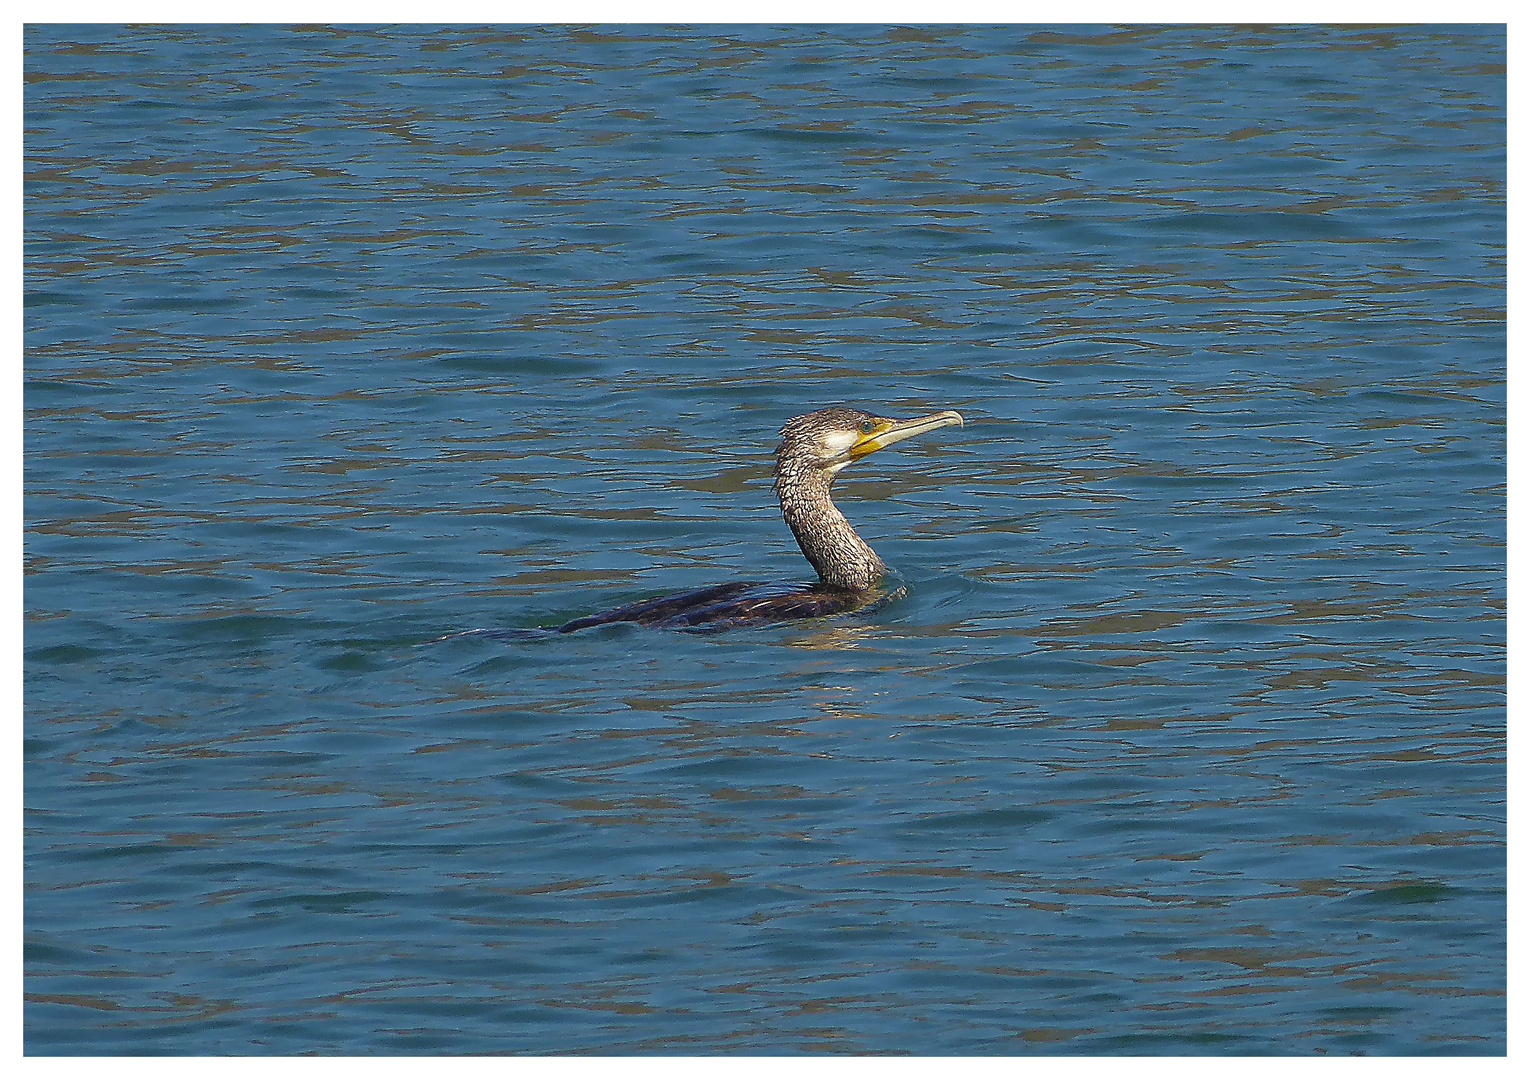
[{"xmin": 24, "ymin": 26, "xmax": 1506, "ymax": 1054}]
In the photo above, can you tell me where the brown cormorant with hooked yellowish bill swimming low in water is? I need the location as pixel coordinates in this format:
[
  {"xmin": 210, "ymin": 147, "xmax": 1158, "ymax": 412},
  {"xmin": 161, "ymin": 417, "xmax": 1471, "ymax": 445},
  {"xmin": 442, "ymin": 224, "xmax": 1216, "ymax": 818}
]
[{"xmin": 552, "ymin": 407, "xmax": 962, "ymax": 633}]
